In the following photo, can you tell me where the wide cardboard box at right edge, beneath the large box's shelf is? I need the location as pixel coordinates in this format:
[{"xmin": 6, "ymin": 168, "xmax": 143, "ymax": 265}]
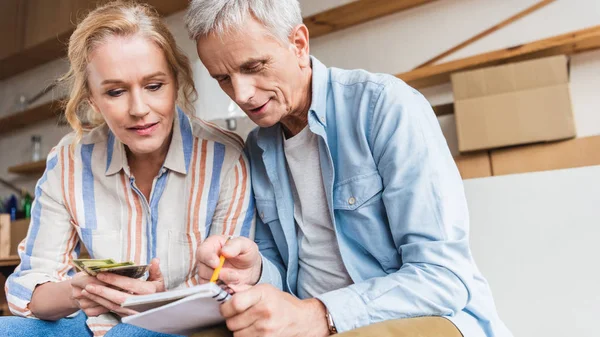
[{"xmin": 491, "ymin": 136, "xmax": 600, "ymax": 175}]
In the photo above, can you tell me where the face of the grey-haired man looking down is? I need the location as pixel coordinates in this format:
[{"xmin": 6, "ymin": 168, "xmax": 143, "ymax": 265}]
[{"xmin": 196, "ymin": 17, "xmax": 310, "ymax": 127}]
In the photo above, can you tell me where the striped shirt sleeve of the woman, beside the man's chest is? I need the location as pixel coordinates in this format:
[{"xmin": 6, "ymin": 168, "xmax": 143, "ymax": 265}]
[{"xmin": 210, "ymin": 153, "xmax": 256, "ymax": 239}]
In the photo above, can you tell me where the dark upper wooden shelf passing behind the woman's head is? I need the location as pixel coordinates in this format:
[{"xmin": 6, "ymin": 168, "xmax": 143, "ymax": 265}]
[{"xmin": 0, "ymin": 0, "xmax": 188, "ymax": 80}]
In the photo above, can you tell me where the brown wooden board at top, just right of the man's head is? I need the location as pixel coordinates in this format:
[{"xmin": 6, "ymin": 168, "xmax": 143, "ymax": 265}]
[{"xmin": 304, "ymin": 0, "xmax": 435, "ymax": 38}]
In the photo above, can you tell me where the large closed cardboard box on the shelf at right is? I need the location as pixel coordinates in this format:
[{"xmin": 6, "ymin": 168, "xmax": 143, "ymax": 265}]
[{"xmin": 451, "ymin": 55, "xmax": 576, "ymax": 152}]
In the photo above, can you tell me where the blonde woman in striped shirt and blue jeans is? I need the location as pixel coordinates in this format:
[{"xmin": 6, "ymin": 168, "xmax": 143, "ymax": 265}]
[{"xmin": 0, "ymin": 2, "xmax": 254, "ymax": 336}]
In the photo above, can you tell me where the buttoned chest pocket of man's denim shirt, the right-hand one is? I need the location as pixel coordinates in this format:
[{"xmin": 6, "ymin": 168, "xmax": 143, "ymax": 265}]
[{"xmin": 333, "ymin": 172, "xmax": 383, "ymax": 211}]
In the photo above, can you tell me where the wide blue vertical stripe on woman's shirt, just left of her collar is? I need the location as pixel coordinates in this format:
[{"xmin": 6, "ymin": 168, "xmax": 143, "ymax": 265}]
[{"xmin": 81, "ymin": 144, "xmax": 97, "ymax": 253}]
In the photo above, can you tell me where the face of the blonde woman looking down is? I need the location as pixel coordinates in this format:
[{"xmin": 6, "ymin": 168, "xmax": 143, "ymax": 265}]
[{"xmin": 88, "ymin": 36, "xmax": 177, "ymax": 155}]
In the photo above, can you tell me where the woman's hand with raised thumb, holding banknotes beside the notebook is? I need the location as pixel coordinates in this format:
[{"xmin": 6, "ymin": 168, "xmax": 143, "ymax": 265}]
[{"xmin": 81, "ymin": 259, "xmax": 165, "ymax": 317}]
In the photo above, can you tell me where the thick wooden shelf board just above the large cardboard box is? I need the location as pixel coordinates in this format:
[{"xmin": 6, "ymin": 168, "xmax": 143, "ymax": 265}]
[{"xmin": 396, "ymin": 26, "xmax": 600, "ymax": 88}]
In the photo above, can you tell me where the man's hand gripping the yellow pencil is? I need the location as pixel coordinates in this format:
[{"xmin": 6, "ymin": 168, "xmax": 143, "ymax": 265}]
[{"xmin": 196, "ymin": 235, "xmax": 262, "ymax": 286}]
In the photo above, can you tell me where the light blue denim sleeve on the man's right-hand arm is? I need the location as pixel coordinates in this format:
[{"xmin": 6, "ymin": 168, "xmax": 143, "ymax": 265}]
[{"xmin": 318, "ymin": 80, "xmax": 473, "ymax": 332}]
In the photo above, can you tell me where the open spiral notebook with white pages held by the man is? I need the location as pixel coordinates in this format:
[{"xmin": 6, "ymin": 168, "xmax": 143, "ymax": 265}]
[{"xmin": 121, "ymin": 283, "xmax": 231, "ymax": 335}]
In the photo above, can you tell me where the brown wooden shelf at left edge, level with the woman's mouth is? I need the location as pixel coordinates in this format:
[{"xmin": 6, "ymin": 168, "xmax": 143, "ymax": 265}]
[{"xmin": 0, "ymin": 101, "xmax": 61, "ymax": 135}]
